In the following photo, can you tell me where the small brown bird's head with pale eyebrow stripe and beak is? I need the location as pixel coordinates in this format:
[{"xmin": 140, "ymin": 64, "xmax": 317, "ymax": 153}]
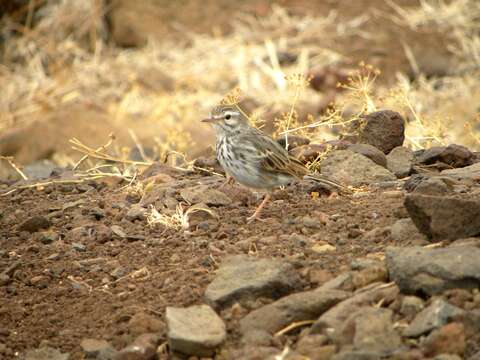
[{"xmin": 202, "ymin": 105, "xmax": 249, "ymax": 134}]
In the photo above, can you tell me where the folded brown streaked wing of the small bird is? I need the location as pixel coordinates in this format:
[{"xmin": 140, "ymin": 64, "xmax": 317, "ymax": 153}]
[{"xmin": 239, "ymin": 129, "xmax": 308, "ymax": 177}]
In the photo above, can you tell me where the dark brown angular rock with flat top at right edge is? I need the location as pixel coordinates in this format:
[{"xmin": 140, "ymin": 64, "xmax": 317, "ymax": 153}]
[{"xmin": 405, "ymin": 194, "xmax": 480, "ymax": 240}]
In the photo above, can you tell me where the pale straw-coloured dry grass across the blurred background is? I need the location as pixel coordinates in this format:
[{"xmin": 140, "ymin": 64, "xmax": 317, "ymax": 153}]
[{"xmin": 0, "ymin": 0, "xmax": 480, "ymax": 173}]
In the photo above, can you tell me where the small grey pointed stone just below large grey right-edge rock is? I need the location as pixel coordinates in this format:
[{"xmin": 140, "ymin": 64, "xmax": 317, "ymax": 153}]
[{"xmin": 403, "ymin": 299, "xmax": 464, "ymax": 337}]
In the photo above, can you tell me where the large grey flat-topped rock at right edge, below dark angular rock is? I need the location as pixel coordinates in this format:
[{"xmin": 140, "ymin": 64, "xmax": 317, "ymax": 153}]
[{"xmin": 386, "ymin": 246, "xmax": 480, "ymax": 295}]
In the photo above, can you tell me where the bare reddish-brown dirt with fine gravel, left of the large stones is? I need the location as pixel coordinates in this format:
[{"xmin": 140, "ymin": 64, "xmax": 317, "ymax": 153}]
[{"xmin": 0, "ymin": 167, "xmax": 407, "ymax": 359}]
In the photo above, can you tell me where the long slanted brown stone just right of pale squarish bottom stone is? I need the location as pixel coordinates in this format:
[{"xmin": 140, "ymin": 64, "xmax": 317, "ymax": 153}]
[{"xmin": 240, "ymin": 288, "xmax": 349, "ymax": 334}]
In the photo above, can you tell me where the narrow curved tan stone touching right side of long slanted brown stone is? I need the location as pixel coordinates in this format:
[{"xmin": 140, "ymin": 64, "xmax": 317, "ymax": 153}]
[{"xmin": 310, "ymin": 284, "xmax": 399, "ymax": 340}]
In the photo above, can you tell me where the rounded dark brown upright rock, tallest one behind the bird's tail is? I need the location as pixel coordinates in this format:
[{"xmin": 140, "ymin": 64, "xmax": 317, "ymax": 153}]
[{"xmin": 347, "ymin": 110, "xmax": 405, "ymax": 154}]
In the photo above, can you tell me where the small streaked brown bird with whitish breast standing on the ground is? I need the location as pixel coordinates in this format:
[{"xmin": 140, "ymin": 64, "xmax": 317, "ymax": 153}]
[{"xmin": 201, "ymin": 104, "xmax": 348, "ymax": 222}]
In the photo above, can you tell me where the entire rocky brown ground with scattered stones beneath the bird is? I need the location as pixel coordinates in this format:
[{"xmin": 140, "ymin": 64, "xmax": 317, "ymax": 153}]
[{"xmin": 0, "ymin": 112, "xmax": 480, "ymax": 360}]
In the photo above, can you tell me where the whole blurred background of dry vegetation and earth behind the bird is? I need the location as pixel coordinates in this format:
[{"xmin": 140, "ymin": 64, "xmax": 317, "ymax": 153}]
[{"xmin": 0, "ymin": 0, "xmax": 480, "ymax": 177}]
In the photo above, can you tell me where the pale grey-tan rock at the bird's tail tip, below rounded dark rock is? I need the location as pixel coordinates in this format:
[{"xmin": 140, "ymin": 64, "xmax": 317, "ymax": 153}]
[{"xmin": 321, "ymin": 150, "xmax": 397, "ymax": 186}]
